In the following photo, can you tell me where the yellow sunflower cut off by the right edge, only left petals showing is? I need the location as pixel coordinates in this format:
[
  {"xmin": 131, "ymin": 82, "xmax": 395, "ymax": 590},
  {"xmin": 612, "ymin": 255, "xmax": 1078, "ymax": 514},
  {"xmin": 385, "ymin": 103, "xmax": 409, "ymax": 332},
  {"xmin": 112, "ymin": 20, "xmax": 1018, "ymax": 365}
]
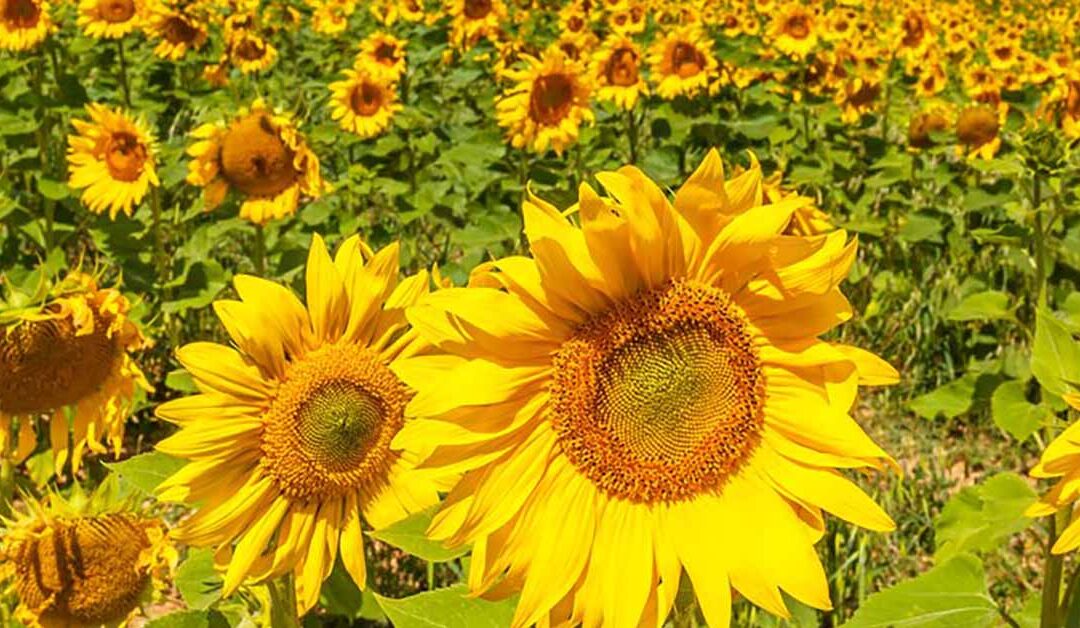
[{"xmin": 1025, "ymin": 392, "xmax": 1080, "ymax": 553}]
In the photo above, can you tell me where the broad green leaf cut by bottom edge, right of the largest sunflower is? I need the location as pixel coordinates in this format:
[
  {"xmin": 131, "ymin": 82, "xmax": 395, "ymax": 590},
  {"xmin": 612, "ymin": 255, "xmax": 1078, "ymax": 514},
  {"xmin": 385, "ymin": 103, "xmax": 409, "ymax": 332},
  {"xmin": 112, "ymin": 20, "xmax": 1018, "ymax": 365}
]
[{"xmin": 843, "ymin": 553, "xmax": 998, "ymax": 628}]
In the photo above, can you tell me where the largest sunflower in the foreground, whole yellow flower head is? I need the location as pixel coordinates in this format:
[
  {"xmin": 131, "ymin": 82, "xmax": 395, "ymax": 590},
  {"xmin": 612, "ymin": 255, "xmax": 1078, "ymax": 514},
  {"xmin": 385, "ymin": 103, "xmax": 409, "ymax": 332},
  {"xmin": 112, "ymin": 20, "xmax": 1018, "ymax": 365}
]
[{"xmin": 395, "ymin": 151, "xmax": 897, "ymax": 628}]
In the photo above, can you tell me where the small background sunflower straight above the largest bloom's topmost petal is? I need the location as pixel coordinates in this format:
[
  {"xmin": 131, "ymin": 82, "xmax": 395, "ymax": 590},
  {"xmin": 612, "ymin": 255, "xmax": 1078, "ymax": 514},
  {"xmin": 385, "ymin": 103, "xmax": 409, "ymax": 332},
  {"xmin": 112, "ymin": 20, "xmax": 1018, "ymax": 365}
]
[{"xmin": 649, "ymin": 26, "xmax": 717, "ymax": 101}]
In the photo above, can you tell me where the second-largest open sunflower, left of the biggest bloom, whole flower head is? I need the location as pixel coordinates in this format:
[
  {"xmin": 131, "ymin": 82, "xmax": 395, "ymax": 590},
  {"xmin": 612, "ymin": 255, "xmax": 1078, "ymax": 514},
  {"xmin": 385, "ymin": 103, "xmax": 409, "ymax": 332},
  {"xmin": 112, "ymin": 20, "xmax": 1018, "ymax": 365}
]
[{"xmin": 158, "ymin": 236, "xmax": 443, "ymax": 614}]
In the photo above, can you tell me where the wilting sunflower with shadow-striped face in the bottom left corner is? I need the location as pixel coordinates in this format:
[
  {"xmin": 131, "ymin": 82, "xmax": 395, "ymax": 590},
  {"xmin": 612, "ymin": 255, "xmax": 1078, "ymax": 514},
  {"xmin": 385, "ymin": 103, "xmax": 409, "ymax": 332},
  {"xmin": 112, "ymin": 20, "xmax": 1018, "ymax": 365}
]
[{"xmin": 0, "ymin": 481, "xmax": 177, "ymax": 628}]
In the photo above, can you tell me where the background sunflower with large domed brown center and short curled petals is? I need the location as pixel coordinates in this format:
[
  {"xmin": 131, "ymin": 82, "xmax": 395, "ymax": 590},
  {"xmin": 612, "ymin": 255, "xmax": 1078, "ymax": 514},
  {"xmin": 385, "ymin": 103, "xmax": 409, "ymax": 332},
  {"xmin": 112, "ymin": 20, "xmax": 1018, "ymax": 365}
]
[{"xmin": 187, "ymin": 98, "xmax": 326, "ymax": 225}]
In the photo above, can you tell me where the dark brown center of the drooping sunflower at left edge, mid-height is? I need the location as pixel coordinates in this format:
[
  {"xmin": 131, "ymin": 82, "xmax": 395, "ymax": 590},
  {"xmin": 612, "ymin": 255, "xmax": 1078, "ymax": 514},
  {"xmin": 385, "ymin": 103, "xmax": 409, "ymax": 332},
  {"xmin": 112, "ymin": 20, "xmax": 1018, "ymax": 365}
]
[{"xmin": 0, "ymin": 318, "xmax": 120, "ymax": 415}]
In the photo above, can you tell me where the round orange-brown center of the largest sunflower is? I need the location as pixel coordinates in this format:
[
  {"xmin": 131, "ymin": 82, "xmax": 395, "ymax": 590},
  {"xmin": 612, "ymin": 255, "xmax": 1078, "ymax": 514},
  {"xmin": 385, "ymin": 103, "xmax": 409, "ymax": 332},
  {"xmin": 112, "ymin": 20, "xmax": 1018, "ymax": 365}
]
[{"xmin": 551, "ymin": 280, "xmax": 765, "ymax": 503}]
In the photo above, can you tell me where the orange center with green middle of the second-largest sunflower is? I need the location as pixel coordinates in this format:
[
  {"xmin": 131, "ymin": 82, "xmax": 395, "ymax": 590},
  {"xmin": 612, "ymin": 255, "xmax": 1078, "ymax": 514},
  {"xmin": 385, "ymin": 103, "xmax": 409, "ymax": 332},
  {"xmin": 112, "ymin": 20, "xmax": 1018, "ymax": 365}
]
[{"xmin": 262, "ymin": 345, "xmax": 408, "ymax": 499}]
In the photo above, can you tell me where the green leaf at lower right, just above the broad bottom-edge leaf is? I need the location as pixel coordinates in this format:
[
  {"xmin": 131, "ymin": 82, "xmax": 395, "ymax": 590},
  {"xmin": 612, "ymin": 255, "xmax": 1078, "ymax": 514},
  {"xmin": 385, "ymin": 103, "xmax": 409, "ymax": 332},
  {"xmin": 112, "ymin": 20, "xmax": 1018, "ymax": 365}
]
[{"xmin": 934, "ymin": 472, "xmax": 1036, "ymax": 561}]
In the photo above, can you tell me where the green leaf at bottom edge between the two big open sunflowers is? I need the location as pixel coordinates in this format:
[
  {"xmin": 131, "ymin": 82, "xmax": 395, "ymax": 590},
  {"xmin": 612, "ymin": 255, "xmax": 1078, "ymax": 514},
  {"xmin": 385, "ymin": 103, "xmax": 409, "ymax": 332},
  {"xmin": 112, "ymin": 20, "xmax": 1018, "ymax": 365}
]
[{"xmin": 375, "ymin": 585, "xmax": 517, "ymax": 628}]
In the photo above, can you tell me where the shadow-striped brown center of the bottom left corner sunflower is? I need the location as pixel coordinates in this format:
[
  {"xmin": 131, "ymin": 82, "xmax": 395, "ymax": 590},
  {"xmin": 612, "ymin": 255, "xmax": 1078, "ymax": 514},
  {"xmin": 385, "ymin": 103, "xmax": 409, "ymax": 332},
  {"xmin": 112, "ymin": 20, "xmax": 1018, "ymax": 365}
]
[{"xmin": 12, "ymin": 515, "xmax": 150, "ymax": 626}]
